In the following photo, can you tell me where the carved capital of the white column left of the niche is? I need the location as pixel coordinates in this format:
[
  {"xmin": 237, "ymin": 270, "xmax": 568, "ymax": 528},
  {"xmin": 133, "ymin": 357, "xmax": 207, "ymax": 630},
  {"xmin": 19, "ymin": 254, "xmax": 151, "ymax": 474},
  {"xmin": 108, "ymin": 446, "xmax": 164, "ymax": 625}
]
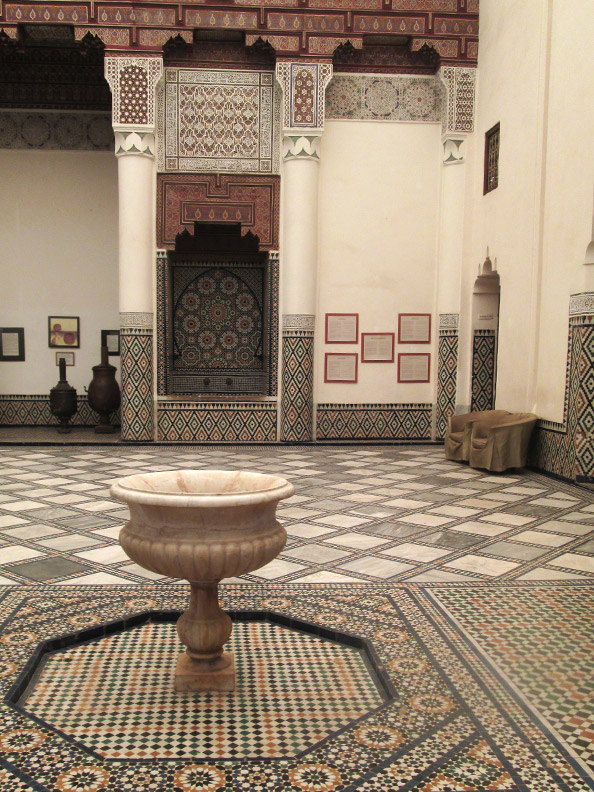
[{"xmin": 105, "ymin": 56, "xmax": 163, "ymax": 136}]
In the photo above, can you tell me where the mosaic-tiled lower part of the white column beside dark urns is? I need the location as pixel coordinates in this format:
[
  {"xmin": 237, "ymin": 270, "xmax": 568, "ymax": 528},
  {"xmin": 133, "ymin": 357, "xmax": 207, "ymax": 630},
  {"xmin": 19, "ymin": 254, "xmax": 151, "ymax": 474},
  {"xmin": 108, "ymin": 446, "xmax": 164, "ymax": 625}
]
[{"xmin": 120, "ymin": 327, "xmax": 154, "ymax": 440}]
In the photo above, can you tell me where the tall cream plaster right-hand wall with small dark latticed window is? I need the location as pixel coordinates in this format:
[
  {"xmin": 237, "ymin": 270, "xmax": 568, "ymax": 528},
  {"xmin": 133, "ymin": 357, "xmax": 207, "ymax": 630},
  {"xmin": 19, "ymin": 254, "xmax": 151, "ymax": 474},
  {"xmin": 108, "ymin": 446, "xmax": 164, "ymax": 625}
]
[{"xmin": 468, "ymin": 0, "xmax": 594, "ymax": 420}]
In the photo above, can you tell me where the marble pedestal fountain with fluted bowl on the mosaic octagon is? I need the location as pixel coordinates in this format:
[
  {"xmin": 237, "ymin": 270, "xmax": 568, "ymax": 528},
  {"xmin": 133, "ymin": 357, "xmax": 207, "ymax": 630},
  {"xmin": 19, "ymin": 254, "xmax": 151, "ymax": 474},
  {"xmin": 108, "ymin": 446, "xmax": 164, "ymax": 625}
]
[{"xmin": 111, "ymin": 470, "xmax": 294, "ymax": 691}]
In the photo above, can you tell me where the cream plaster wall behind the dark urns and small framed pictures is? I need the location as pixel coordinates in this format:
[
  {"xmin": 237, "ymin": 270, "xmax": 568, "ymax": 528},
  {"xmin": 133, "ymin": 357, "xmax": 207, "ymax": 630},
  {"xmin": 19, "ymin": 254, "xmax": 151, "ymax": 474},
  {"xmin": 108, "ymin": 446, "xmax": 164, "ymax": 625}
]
[{"xmin": 0, "ymin": 151, "xmax": 120, "ymax": 395}]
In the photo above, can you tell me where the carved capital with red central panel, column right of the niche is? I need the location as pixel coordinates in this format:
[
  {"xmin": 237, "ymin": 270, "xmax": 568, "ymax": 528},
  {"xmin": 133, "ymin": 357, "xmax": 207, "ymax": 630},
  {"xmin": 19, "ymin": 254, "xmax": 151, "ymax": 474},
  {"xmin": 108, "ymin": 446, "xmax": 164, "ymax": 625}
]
[{"xmin": 276, "ymin": 61, "xmax": 332, "ymax": 134}]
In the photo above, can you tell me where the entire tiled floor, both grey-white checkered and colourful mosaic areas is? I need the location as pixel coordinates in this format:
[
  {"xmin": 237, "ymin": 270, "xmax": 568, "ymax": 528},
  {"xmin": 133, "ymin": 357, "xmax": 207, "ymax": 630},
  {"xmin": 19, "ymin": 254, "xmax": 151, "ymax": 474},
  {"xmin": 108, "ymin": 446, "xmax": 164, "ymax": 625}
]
[{"xmin": 0, "ymin": 441, "xmax": 594, "ymax": 792}]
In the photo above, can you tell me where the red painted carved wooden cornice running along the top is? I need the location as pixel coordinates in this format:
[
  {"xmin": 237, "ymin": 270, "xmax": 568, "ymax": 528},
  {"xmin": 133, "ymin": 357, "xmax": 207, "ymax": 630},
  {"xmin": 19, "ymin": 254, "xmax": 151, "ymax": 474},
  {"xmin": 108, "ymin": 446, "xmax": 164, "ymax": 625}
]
[{"xmin": 0, "ymin": 0, "xmax": 479, "ymax": 65}]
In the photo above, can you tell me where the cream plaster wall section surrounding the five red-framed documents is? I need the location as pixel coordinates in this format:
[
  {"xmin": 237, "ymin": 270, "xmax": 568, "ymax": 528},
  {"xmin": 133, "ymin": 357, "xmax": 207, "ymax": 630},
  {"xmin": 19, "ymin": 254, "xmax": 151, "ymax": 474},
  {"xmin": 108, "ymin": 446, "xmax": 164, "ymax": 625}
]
[{"xmin": 315, "ymin": 121, "xmax": 441, "ymax": 404}]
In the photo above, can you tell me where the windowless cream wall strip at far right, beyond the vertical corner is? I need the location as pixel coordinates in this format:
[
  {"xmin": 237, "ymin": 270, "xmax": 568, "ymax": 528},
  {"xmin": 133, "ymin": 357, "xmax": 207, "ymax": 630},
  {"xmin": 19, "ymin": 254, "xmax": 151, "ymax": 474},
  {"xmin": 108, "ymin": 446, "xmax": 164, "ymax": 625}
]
[{"xmin": 535, "ymin": 0, "xmax": 594, "ymax": 421}]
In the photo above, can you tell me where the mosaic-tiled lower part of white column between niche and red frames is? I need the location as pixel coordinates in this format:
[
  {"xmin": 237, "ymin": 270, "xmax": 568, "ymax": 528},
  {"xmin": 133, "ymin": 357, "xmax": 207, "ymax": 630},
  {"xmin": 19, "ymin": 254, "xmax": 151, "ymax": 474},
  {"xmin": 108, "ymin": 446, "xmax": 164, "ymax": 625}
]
[{"xmin": 281, "ymin": 328, "xmax": 314, "ymax": 443}]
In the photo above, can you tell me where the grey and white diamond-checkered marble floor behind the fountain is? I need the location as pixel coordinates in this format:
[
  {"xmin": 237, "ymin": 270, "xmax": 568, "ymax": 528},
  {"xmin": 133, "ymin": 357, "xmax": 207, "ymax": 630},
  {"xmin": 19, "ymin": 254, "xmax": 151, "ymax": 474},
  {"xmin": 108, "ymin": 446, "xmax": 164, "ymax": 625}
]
[{"xmin": 0, "ymin": 446, "xmax": 594, "ymax": 585}]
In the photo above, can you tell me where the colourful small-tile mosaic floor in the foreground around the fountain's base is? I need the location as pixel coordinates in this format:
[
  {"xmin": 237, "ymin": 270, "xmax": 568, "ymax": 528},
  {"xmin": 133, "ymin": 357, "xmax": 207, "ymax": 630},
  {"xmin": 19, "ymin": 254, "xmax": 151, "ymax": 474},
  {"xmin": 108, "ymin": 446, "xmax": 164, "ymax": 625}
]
[{"xmin": 0, "ymin": 582, "xmax": 594, "ymax": 792}]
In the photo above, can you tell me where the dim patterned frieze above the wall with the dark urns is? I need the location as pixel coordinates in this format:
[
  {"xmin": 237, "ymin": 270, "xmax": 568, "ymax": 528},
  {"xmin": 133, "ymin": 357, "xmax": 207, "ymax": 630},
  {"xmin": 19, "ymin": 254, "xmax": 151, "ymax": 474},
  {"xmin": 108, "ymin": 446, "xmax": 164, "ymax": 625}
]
[{"xmin": 0, "ymin": 110, "xmax": 113, "ymax": 151}]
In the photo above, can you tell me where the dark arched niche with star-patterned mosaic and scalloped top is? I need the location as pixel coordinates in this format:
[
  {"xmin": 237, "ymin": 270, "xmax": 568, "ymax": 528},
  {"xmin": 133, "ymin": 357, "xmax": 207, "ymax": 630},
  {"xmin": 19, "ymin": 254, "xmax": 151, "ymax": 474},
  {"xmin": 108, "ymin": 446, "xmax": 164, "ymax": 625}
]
[{"xmin": 164, "ymin": 223, "xmax": 271, "ymax": 396}]
